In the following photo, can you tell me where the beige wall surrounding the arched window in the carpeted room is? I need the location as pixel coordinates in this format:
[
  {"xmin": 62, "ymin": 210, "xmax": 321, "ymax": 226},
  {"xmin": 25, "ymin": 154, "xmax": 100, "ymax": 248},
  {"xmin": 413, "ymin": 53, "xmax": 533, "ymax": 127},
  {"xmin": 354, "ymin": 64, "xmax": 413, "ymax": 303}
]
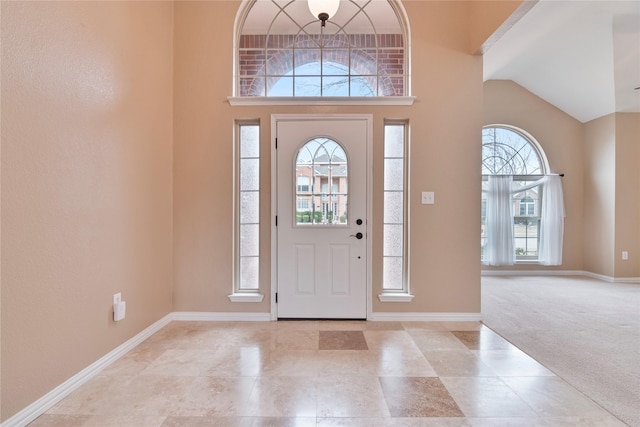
[{"xmin": 483, "ymin": 80, "xmax": 584, "ymax": 270}]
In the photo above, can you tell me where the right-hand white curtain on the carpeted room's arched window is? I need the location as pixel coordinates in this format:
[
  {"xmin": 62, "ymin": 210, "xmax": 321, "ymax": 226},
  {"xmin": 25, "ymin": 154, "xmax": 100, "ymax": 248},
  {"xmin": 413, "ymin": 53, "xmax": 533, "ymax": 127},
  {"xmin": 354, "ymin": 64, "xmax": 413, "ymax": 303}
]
[{"xmin": 538, "ymin": 175, "xmax": 565, "ymax": 265}]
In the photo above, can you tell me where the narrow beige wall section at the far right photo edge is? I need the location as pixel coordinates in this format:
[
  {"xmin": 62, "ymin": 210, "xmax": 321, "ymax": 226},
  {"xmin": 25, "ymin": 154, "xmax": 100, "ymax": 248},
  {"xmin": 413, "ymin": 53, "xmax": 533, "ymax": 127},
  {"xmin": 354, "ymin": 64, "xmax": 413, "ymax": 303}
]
[{"xmin": 613, "ymin": 113, "xmax": 640, "ymax": 278}]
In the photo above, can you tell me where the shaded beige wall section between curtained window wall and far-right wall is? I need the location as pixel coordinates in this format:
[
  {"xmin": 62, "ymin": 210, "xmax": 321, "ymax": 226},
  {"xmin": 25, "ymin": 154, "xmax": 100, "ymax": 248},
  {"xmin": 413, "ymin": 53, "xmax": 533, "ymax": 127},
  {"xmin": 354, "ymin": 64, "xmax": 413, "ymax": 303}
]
[{"xmin": 583, "ymin": 114, "xmax": 616, "ymax": 277}]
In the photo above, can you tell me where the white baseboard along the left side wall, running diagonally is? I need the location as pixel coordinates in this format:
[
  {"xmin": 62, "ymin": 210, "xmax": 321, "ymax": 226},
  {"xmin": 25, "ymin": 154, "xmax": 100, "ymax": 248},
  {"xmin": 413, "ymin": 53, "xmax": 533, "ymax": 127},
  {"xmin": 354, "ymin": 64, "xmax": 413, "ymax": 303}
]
[{"xmin": 2, "ymin": 314, "xmax": 171, "ymax": 427}]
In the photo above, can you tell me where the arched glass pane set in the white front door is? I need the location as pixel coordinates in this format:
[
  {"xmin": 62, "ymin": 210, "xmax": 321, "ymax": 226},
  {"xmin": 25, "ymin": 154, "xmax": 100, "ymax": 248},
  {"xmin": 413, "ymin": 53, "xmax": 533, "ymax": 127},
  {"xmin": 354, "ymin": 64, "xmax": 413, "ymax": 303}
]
[{"xmin": 295, "ymin": 137, "xmax": 349, "ymax": 225}]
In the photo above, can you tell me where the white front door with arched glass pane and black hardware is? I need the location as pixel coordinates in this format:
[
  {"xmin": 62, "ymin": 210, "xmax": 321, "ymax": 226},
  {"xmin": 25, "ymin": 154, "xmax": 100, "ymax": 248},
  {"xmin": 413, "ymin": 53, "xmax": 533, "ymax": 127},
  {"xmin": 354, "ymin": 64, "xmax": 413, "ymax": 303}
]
[{"xmin": 276, "ymin": 116, "xmax": 371, "ymax": 319}]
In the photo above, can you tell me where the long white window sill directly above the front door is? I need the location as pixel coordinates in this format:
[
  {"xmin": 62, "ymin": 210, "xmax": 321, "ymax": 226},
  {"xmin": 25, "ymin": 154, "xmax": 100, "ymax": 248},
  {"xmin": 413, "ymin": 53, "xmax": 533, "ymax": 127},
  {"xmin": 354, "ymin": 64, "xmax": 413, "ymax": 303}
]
[{"xmin": 227, "ymin": 96, "xmax": 416, "ymax": 107}]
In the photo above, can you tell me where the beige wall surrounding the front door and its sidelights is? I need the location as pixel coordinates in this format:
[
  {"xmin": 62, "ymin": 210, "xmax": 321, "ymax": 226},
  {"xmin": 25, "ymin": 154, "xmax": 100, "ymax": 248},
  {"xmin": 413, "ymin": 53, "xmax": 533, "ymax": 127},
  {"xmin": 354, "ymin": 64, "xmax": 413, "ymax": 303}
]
[{"xmin": 174, "ymin": 1, "xmax": 482, "ymax": 313}]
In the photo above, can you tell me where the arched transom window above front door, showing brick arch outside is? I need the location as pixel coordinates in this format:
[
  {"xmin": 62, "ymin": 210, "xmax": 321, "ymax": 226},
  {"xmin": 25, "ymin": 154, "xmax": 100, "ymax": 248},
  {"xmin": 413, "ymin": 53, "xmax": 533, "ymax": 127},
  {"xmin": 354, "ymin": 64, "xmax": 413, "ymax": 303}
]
[{"xmin": 234, "ymin": 0, "xmax": 408, "ymax": 97}]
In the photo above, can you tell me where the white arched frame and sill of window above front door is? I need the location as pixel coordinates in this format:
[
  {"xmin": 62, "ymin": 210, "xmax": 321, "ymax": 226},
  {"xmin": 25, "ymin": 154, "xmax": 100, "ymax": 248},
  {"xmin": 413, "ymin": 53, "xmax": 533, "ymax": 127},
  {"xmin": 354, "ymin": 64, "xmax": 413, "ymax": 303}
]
[{"xmin": 227, "ymin": 0, "xmax": 415, "ymax": 106}]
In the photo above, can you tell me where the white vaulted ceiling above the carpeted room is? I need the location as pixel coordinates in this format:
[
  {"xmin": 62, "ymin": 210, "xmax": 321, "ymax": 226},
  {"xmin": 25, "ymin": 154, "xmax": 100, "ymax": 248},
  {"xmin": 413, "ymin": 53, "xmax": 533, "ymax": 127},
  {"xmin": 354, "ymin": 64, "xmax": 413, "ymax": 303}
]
[{"xmin": 483, "ymin": 0, "xmax": 640, "ymax": 122}]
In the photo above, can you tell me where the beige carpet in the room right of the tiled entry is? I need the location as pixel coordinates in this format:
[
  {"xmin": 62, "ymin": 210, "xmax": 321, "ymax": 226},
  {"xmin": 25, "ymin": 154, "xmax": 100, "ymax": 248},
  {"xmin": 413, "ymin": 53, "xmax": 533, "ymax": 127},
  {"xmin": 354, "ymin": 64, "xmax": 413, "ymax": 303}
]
[{"xmin": 482, "ymin": 276, "xmax": 640, "ymax": 427}]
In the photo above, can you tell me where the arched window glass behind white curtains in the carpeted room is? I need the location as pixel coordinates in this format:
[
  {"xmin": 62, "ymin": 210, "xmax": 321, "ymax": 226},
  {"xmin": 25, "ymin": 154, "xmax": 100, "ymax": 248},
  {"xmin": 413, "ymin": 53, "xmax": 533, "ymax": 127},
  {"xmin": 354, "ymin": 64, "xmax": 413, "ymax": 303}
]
[{"xmin": 481, "ymin": 125, "xmax": 549, "ymax": 265}]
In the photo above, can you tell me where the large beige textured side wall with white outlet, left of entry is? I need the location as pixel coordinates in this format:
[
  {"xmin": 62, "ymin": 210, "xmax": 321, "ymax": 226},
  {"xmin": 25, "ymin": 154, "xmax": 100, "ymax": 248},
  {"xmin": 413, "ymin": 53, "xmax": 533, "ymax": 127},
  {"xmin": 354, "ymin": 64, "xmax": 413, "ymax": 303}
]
[{"xmin": 0, "ymin": 2, "xmax": 173, "ymax": 420}]
